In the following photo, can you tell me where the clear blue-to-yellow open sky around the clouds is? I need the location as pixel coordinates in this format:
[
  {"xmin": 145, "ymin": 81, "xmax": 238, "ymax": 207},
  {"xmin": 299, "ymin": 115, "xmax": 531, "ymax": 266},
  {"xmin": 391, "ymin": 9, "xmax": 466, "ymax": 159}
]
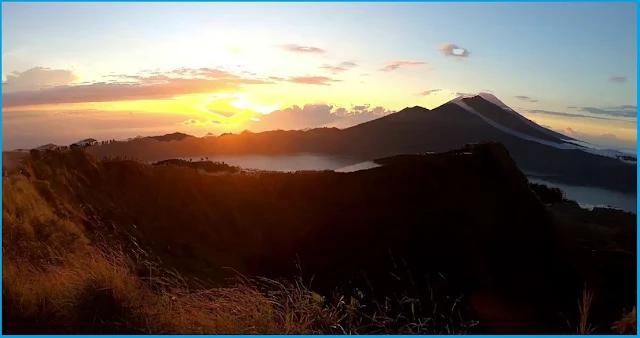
[{"xmin": 2, "ymin": 3, "xmax": 637, "ymax": 147}]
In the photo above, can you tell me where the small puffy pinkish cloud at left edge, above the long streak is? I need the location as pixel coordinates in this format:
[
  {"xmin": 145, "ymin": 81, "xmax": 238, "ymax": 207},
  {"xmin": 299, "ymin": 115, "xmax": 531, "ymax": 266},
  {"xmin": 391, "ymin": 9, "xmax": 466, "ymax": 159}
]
[{"xmin": 2, "ymin": 67, "xmax": 78, "ymax": 93}]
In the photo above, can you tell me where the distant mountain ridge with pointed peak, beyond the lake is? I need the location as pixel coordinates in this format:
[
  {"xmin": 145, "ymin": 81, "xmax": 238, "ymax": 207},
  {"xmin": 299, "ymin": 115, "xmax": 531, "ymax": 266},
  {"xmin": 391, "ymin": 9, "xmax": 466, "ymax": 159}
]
[{"xmin": 89, "ymin": 96, "xmax": 637, "ymax": 194}]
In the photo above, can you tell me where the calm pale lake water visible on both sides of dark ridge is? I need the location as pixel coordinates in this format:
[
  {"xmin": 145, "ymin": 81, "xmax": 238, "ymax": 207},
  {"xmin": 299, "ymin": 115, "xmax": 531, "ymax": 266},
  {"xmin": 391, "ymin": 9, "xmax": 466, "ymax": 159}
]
[{"xmin": 185, "ymin": 154, "xmax": 637, "ymax": 213}]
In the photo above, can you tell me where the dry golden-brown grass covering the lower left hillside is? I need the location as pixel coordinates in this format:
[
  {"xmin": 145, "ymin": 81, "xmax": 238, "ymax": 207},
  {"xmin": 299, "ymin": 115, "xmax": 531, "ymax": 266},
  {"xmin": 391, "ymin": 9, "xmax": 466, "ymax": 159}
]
[{"xmin": 2, "ymin": 176, "xmax": 476, "ymax": 334}]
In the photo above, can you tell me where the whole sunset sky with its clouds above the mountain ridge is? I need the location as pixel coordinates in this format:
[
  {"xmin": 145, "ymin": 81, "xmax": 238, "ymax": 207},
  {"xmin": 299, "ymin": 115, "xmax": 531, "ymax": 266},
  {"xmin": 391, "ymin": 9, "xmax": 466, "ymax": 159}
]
[{"xmin": 2, "ymin": 2, "xmax": 637, "ymax": 150}]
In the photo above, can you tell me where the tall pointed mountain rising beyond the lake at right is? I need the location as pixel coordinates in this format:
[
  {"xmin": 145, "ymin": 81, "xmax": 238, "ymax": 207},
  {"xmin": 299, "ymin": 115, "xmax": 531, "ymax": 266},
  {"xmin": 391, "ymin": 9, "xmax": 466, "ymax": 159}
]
[{"xmin": 324, "ymin": 96, "xmax": 637, "ymax": 193}]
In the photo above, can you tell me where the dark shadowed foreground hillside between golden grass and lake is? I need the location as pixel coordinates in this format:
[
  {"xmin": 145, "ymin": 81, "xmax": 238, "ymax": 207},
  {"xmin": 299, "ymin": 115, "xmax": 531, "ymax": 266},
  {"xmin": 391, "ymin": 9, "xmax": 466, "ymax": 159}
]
[{"xmin": 3, "ymin": 144, "xmax": 636, "ymax": 333}]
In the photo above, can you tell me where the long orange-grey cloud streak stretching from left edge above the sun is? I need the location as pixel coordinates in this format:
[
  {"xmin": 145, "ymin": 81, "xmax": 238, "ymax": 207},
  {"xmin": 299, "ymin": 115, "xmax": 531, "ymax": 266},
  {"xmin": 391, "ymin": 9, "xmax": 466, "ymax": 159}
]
[{"xmin": 2, "ymin": 68, "xmax": 274, "ymax": 108}]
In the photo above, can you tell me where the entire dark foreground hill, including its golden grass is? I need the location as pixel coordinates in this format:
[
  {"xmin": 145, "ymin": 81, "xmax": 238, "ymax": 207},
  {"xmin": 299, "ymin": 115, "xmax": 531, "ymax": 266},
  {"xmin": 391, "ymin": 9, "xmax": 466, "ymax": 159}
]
[{"xmin": 2, "ymin": 142, "xmax": 636, "ymax": 333}]
